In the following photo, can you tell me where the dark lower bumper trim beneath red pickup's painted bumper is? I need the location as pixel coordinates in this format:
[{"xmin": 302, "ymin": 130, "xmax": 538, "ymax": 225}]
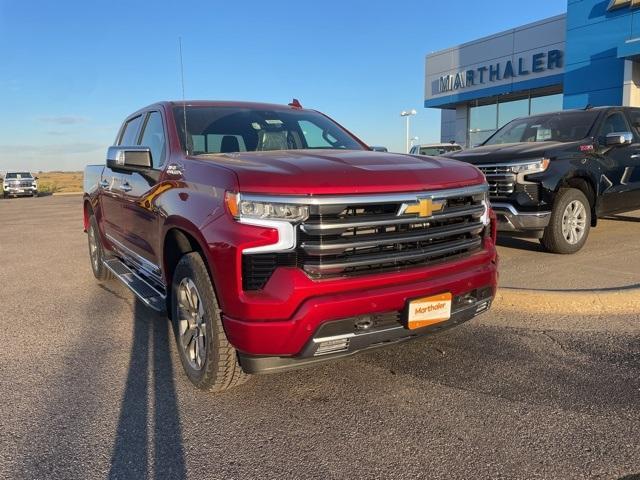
[{"xmin": 239, "ymin": 287, "xmax": 493, "ymax": 374}]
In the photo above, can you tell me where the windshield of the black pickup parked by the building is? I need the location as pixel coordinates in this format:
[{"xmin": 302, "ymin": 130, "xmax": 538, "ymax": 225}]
[{"xmin": 483, "ymin": 111, "xmax": 599, "ymax": 145}]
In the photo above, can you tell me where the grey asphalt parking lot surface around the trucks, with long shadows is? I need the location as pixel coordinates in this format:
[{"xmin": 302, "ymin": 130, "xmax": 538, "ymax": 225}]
[{"xmin": 0, "ymin": 196, "xmax": 640, "ymax": 480}]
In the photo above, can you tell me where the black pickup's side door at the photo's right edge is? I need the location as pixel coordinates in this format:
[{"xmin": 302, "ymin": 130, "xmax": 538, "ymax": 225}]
[{"xmin": 598, "ymin": 110, "xmax": 640, "ymax": 214}]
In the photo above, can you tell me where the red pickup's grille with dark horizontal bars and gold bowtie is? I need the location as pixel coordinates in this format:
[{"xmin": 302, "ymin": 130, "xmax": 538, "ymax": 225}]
[{"xmin": 297, "ymin": 185, "xmax": 486, "ymax": 278}]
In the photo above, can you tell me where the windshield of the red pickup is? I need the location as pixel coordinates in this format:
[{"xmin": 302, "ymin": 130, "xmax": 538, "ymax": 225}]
[{"xmin": 174, "ymin": 107, "xmax": 364, "ymax": 155}]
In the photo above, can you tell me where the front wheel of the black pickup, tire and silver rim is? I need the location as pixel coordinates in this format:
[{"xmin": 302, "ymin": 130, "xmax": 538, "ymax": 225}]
[{"xmin": 540, "ymin": 188, "xmax": 591, "ymax": 254}]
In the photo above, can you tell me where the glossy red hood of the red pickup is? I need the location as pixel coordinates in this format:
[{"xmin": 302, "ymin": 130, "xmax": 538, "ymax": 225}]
[{"xmin": 194, "ymin": 150, "xmax": 484, "ymax": 195}]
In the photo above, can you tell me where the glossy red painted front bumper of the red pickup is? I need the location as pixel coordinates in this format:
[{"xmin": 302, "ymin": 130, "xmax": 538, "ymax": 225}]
[{"xmin": 223, "ymin": 248, "xmax": 498, "ymax": 357}]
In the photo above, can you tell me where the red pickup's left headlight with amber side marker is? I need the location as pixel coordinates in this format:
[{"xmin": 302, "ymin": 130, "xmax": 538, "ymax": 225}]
[{"xmin": 225, "ymin": 192, "xmax": 309, "ymax": 223}]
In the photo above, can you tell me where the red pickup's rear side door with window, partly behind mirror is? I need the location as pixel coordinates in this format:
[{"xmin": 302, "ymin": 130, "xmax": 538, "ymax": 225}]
[{"xmin": 100, "ymin": 115, "xmax": 143, "ymax": 245}]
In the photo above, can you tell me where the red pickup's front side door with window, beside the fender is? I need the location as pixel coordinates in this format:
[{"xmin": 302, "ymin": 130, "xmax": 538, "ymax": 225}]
[{"xmin": 121, "ymin": 110, "xmax": 168, "ymax": 278}]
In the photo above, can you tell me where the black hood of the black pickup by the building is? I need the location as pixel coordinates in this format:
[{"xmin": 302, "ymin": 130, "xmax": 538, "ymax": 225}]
[{"xmin": 447, "ymin": 140, "xmax": 588, "ymax": 165}]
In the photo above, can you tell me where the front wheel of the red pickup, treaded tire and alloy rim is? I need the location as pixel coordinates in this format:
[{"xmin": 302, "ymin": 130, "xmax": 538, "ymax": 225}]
[{"xmin": 171, "ymin": 252, "xmax": 249, "ymax": 392}]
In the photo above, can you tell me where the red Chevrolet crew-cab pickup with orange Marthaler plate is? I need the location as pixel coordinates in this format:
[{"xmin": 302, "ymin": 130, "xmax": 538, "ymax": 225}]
[{"xmin": 84, "ymin": 101, "xmax": 497, "ymax": 391}]
